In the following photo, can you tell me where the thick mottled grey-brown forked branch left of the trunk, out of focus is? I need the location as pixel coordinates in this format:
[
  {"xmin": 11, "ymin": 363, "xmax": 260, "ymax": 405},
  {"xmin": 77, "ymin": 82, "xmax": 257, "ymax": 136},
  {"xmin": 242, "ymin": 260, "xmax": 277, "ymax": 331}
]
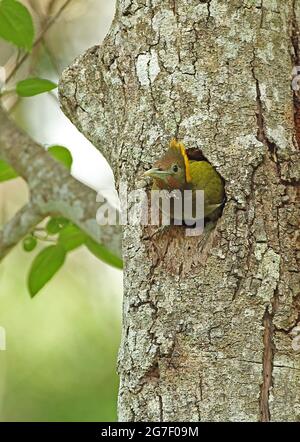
[{"xmin": 0, "ymin": 107, "xmax": 121, "ymax": 257}]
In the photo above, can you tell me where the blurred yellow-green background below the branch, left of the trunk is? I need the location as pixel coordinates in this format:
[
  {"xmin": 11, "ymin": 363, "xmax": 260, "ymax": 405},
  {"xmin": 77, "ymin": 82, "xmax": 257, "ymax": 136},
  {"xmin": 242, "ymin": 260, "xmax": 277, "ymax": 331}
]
[{"xmin": 0, "ymin": 248, "xmax": 120, "ymax": 421}]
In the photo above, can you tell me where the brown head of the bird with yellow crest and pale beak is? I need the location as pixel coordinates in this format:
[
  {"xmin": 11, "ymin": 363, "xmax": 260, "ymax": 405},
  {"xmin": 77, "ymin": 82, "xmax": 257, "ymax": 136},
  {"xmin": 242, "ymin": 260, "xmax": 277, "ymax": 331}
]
[{"xmin": 145, "ymin": 139, "xmax": 191, "ymax": 190}]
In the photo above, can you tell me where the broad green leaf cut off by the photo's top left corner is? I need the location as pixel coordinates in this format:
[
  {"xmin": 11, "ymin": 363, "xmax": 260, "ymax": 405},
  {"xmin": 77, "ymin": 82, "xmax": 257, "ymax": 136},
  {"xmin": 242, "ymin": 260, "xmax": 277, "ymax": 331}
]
[{"xmin": 0, "ymin": 0, "xmax": 34, "ymax": 51}]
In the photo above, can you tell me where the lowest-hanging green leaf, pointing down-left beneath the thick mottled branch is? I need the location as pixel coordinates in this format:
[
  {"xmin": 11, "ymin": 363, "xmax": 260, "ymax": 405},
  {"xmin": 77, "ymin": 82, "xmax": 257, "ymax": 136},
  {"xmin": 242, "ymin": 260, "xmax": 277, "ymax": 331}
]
[{"xmin": 28, "ymin": 244, "xmax": 66, "ymax": 298}]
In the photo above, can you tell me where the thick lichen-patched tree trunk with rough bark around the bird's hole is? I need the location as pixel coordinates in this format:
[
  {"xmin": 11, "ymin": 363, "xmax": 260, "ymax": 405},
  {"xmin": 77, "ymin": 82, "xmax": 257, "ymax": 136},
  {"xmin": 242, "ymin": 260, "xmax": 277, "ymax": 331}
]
[{"xmin": 60, "ymin": 0, "xmax": 300, "ymax": 421}]
